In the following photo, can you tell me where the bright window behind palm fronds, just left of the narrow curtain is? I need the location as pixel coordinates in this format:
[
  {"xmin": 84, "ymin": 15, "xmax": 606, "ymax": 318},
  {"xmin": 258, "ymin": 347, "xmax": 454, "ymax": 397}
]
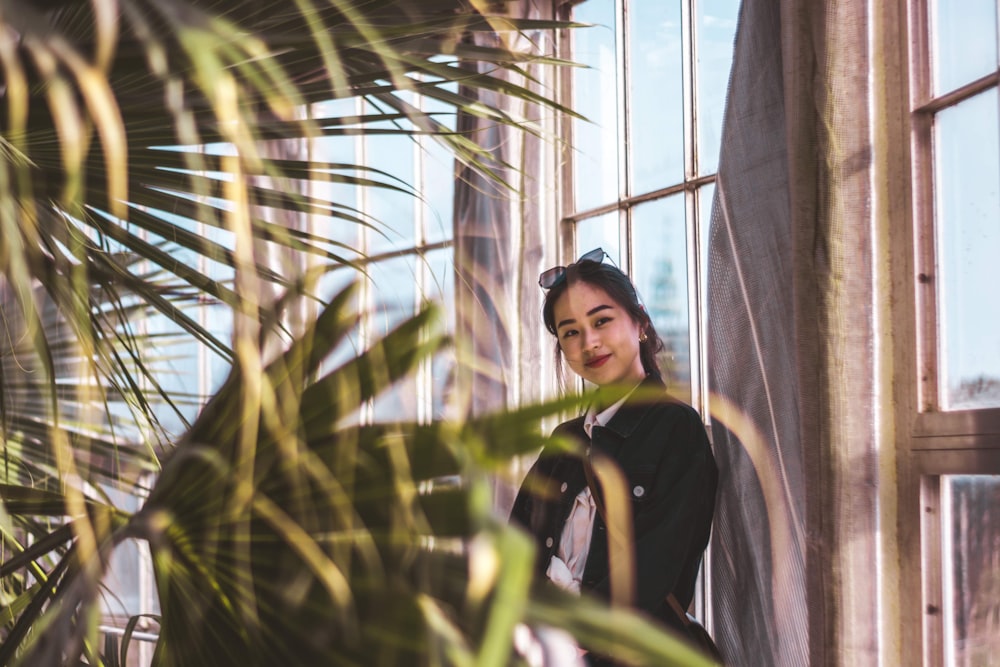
[{"xmin": 312, "ymin": 98, "xmax": 455, "ymax": 421}]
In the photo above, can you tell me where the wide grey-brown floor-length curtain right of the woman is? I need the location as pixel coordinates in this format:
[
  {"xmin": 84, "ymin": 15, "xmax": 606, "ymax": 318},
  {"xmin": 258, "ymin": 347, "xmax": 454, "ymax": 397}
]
[{"xmin": 708, "ymin": 0, "xmax": 879, "ymax": 667}]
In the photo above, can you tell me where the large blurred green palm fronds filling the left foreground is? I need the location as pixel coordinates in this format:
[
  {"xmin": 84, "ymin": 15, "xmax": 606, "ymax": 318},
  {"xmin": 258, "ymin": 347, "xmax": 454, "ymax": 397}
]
[{"xmin": 0, "ymin": 0, "xmax": 712, "ymax": 666}]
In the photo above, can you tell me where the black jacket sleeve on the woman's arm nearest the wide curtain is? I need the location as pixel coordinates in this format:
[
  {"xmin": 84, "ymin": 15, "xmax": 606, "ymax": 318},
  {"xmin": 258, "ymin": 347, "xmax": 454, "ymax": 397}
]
[{"xmin": 593, "ymin": 406, "xmax": 718, "ymax": 613}]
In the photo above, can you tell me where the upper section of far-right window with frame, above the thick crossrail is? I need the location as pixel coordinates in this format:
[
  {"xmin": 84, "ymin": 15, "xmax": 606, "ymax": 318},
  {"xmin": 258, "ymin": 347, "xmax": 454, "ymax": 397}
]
[{"xmin": 915, "ymin": 0, "xmax": 1000, "ymax": 411}]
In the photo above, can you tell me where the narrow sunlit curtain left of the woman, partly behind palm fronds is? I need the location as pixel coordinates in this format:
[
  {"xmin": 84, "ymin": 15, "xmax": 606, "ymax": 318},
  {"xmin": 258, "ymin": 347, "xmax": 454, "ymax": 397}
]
[{"xmin": 454, "ymin": 0, "xmax": 558, "ymax": 515}]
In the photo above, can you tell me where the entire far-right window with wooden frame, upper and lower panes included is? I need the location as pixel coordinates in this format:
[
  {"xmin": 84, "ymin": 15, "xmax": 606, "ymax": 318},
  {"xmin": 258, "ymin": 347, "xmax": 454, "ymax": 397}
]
[{"xmin": 899, "ymin": 0, "xmax": 1000, "ymax": 665}]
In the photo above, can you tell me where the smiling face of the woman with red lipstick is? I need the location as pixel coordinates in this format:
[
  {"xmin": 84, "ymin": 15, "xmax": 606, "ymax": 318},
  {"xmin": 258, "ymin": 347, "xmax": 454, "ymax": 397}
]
[{"xmin": 552, "ymin": 281, "xmax": 646, "ymax": 386}]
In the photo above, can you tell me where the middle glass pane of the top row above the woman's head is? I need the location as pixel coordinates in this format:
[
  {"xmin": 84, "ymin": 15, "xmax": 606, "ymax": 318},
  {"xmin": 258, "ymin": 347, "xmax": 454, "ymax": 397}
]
[{"xmin": 628, "ymin": 2, "xmax": 684, "ymax": 195}]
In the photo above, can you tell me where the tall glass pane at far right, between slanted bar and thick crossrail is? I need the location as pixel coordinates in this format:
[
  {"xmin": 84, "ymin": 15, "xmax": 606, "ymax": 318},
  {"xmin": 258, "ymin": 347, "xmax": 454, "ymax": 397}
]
[{"xmin": 934, "ymin": 89, "xmax": 1000, "ymax": 410}]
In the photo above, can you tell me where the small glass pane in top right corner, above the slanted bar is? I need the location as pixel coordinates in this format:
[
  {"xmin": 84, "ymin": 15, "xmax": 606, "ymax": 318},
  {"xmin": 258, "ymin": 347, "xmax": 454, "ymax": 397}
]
[{"xmin": 930, "ymin": 0, "xmax": 997, "ymax": 95}]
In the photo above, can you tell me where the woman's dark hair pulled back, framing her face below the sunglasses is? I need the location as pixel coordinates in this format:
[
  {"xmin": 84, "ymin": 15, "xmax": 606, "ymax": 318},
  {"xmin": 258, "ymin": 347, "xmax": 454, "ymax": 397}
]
[{"xmin": 542, "ymin": 260, "xmax": 663, "ymax": 378}]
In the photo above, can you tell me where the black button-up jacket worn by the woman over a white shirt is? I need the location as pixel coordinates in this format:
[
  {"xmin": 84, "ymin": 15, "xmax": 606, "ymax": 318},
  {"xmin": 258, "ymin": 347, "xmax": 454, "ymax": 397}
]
[{"xmin": 511, "ymin": 378, "xmax": 718, "ymax": 630}]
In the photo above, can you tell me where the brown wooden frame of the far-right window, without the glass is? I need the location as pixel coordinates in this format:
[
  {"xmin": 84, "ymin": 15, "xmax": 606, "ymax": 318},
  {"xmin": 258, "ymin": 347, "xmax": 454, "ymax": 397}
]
[{"xmin": 904, "ymin": 0, "xmax": 1000, "ymax": 666}]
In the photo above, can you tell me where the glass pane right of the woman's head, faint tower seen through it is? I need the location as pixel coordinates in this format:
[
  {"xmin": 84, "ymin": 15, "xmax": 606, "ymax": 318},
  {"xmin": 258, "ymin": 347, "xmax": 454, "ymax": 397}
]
[{"xmin": 632, "ymin": 195, "xmax": 691, "ymax": 393}]
